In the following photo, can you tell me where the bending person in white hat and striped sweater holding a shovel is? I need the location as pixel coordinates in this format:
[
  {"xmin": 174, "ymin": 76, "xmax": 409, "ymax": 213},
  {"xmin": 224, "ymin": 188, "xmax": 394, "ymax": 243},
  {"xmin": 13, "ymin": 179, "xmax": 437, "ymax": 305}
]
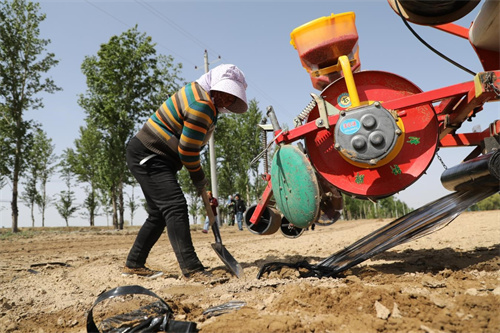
[{"xmin": 122, "ymin": 65, "xmax": 248, "ymax": 281}]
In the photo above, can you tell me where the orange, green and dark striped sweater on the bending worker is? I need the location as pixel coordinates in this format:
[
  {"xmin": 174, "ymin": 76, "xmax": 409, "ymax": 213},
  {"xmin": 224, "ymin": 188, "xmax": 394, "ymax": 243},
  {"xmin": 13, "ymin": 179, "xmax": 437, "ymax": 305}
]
[{"xmin": 136, "ymin": 82, "xmax": 217, "ymax": 182}]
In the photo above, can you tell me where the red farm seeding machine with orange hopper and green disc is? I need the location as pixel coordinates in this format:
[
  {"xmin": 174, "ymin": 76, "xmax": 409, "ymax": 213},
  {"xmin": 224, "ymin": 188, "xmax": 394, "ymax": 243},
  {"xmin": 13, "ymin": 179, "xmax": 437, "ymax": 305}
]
[{"xmin": 245, "ymin": 0, "xmax": 500, "ymax": 256}]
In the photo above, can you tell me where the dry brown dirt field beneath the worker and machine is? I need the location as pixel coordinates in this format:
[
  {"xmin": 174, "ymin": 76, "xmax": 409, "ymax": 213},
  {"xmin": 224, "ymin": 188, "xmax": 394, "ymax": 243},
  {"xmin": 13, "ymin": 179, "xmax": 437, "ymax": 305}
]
[{"xmin": 0, "ymin": 211, "xmax": 500, "ymax": 333}]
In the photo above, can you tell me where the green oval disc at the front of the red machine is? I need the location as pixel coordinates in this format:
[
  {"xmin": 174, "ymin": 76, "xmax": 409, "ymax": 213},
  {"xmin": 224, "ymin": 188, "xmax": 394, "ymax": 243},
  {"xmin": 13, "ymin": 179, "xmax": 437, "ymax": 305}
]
[{"xmin": 271, "ymin": 145, "xmax": 320, "ymax": 228}]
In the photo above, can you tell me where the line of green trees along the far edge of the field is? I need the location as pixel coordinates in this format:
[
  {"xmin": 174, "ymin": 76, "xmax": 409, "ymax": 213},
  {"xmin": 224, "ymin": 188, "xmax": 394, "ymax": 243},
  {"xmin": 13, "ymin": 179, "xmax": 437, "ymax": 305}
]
[{"xmin": 0, "ymin": 0, "xmax": 499, "ymax": 232}]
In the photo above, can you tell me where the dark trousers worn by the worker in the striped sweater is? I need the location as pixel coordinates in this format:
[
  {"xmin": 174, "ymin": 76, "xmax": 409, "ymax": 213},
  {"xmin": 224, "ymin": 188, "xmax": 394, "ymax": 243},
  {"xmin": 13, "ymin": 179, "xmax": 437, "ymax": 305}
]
[{"xmin": 126, "ymin": 137, "xmax": 203, "ymax": 274}]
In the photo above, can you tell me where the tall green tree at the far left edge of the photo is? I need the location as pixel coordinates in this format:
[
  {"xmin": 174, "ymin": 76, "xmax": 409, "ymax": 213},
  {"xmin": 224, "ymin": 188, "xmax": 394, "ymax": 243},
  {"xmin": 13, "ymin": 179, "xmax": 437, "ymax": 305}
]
[{"xmin": 0, "ymin": 0, "xmax": 60, "ymax": 232}]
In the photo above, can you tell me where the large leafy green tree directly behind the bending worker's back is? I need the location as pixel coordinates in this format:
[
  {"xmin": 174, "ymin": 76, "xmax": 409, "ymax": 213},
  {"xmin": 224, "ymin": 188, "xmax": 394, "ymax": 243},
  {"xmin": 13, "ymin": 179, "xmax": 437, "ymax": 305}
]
[{"xmin": 78, "ymin": 26, "xmax": 181, "ymax": 229}]
